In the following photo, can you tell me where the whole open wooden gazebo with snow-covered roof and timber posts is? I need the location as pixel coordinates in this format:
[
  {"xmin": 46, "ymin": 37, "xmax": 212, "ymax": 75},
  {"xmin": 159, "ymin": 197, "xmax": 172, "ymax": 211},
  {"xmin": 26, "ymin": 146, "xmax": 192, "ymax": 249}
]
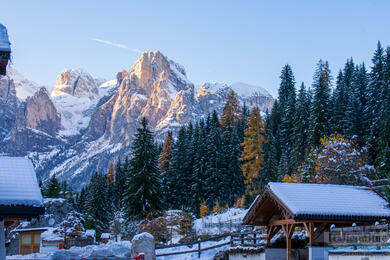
[{"xmin": 243, "ymin": 183, "xmax": 390, "ymax": 260}]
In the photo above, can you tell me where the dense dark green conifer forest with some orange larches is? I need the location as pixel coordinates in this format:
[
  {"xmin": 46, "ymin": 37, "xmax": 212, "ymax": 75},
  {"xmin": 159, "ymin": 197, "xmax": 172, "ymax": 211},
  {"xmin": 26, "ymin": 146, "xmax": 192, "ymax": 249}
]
[{"xmin": 41, "ymin": 42, "xmax": 390, "ymax": 239}]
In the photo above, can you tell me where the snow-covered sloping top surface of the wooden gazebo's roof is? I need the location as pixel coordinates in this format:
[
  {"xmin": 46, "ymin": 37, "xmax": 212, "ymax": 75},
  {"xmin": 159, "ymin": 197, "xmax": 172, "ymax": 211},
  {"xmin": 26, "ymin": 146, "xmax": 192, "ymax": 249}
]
[{"xmin": 268, "ymin": 183, "xmax": 390, "ymax": 217}]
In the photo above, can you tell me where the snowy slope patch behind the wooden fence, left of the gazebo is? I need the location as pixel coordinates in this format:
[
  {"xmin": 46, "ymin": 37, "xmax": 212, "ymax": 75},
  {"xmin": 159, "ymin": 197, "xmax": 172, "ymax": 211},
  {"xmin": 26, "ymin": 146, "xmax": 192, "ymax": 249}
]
[{"xmin": 194, "ymin": 208, "xmax": 247, "ymax": 235}]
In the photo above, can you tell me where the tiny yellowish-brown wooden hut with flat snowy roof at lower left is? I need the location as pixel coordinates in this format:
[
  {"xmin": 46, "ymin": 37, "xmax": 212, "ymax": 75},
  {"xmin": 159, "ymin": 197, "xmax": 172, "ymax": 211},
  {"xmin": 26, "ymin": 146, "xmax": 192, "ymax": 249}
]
[{"xmin": 13, "ymin": 228, "xmax": 47, "ymax": 255}]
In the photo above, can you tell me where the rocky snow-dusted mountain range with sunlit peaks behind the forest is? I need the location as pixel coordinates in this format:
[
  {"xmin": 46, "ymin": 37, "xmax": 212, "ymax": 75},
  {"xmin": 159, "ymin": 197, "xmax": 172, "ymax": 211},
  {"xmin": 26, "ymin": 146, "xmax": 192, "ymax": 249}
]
[{"xmin": 0, "ymin": 51, "xmax": 273, "ymax": 189}]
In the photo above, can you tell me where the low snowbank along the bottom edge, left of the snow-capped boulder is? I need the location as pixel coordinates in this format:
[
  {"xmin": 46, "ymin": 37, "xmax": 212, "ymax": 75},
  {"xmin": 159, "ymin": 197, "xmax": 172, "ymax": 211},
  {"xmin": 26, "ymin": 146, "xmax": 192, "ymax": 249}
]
[{"xmin": 7, "ymin": 241, "xmax": 131, "ymax": 260}]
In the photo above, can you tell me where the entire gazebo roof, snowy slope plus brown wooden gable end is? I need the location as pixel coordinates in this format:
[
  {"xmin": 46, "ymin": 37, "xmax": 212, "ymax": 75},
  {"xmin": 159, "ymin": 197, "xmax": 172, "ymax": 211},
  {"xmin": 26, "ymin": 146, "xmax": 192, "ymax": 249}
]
[{"xmin": 244, "ymin": 183, "xmax": 390, "ymax": 224}]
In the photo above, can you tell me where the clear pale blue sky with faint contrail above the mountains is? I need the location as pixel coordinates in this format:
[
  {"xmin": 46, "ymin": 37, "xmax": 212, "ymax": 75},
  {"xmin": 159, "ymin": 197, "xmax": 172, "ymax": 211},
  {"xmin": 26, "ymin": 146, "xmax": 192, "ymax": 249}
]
[{"xmin": 0, "ymin": 0, "xmax": 390, "ymax": 96}]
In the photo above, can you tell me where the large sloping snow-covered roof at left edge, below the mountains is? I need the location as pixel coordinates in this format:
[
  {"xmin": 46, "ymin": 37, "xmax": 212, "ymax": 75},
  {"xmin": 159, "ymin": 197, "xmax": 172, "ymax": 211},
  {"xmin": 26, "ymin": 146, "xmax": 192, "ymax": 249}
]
[{"xmin": 0, "ymin": 156, "xmax": 43, "ymax": 207}]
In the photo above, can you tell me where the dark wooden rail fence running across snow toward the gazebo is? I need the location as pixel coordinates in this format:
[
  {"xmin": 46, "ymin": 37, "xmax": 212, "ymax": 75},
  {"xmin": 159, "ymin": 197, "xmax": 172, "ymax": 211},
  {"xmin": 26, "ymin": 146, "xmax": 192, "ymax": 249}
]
[{"xmin": 156, "ymin": 232, "xmax": 266, "ymax": 258}]
